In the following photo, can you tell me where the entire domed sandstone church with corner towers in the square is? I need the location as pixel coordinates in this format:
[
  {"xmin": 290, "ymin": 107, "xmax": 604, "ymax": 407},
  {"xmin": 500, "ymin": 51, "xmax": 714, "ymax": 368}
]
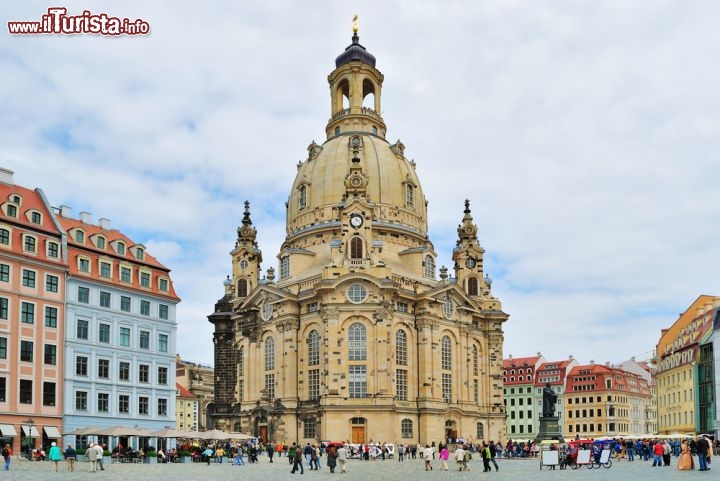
[{"xmin": 208, "ymin": 27, "xmax": 508, "ymax": 444}]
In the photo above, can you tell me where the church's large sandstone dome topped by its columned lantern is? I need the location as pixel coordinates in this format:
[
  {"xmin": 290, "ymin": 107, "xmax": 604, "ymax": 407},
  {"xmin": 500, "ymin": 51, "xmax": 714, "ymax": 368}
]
[{"xmin": 279, "ymin": 33, "xmax": 435, "ymax": 283}]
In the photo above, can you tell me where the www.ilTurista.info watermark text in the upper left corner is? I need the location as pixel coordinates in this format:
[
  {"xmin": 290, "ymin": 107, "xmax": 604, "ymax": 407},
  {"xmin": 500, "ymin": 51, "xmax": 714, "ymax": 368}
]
[{"xmin": 8, "ymin": 7, "xmax": 150, "ymax": 35}]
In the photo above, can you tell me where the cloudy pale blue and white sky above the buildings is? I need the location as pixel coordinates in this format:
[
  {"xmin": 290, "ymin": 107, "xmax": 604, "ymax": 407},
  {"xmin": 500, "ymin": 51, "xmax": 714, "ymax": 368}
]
[{"xmin": 0, "ymin": 0, "xmax": 720, "ymax": 364}]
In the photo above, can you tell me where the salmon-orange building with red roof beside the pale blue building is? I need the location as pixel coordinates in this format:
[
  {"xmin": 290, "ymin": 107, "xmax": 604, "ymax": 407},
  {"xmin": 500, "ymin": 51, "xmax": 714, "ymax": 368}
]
[{"xmin": 0, "ymin": 169, "xmax": 67, "ymax": 451}]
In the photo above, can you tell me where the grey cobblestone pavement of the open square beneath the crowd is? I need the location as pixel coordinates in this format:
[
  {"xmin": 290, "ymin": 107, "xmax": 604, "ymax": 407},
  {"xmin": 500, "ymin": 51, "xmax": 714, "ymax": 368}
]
[{"xmin": 0, "ymin": 457, "xmax": 717, "ymax": 481}]
